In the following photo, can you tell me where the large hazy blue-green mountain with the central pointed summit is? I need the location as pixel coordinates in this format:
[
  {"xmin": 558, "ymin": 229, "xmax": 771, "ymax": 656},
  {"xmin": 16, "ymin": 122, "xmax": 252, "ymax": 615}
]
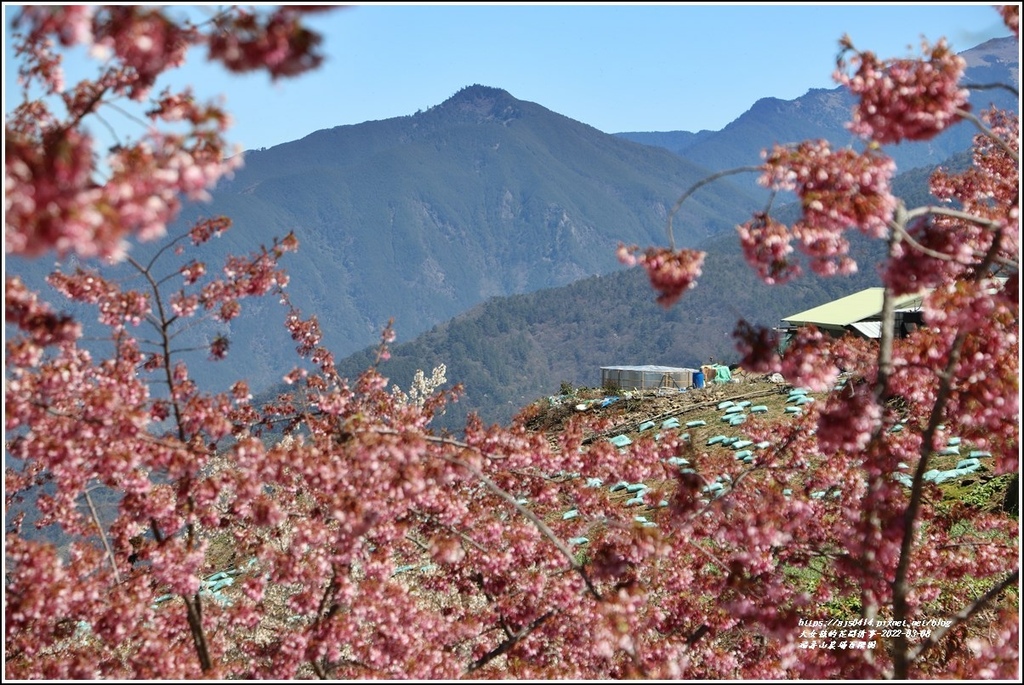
[{"xmin": 149, "ymin": 80, "xmax": 756, "ymax": 389}]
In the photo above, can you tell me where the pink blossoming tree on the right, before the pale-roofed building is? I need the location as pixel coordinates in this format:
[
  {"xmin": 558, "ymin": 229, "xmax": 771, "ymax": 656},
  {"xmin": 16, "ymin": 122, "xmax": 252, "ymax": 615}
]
[{"xmin": 620, "ymin": 5, "xmax": 1020, "ymax": 678}]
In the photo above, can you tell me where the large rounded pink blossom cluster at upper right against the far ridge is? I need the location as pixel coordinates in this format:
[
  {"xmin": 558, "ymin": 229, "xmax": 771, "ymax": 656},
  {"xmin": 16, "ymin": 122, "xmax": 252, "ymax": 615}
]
[{"xmin": 835, "ymin": 39, "xmax": 968, "ymax": 144}]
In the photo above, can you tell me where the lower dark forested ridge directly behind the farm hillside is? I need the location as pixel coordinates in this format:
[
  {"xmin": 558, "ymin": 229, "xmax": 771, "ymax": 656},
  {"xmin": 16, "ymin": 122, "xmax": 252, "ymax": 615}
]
[{"xmin": 338, "ymin": 148, "xmax": 946, "ymax": 431}]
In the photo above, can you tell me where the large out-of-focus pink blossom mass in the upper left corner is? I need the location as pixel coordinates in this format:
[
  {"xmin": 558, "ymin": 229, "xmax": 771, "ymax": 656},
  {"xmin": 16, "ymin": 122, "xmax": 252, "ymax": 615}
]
[{"xmin": 4, "ymin": 5, "xmax": 322, "ymax": 258}]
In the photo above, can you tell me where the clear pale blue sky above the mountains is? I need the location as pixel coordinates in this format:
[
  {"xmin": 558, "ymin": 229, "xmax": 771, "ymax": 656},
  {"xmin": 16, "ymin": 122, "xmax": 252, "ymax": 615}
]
[{"xmin": 5, "ymin": 3, "xmax": 1009, "ymax": 148}]
